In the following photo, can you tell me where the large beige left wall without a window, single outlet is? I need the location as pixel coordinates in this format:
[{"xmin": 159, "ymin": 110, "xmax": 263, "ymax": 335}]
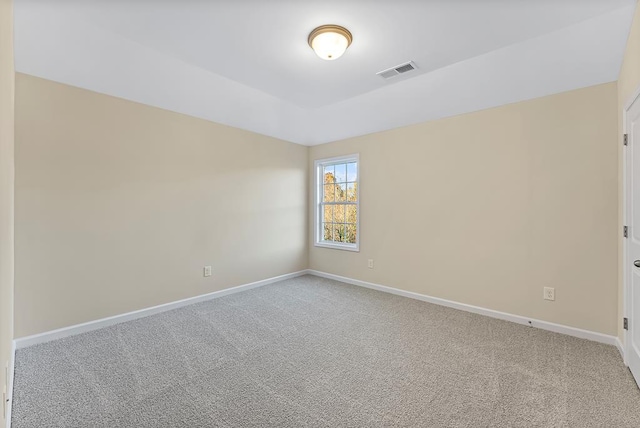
[{"xmin": 15, "ymin": 74, "xmax": 308, "ymax": 337}]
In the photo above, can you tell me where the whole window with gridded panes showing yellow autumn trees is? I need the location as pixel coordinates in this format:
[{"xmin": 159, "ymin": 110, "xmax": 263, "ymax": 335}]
[{"xmin": 315, "ymin": 155, "xmax": 360, "ymax": 251}]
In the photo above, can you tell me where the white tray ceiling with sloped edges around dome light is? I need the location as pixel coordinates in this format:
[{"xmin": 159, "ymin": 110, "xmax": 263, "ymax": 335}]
[{"xmin": 15, "ymin": 0, "xmax": 636, "ymax": 145}]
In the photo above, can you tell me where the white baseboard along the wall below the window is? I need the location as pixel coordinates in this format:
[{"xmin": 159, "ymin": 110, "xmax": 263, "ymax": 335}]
[{"xmin": 307, "ymin": 269, "xmax": 622, "ymax": 349}]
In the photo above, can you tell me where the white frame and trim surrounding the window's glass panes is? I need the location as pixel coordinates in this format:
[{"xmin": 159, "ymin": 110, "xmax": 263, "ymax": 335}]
[{"xmin": 314, "ymin": 153, "xmax": 361, "ymax": 252}]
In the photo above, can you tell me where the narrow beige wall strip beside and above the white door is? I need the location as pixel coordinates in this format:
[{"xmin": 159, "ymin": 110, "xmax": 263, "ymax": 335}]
[{"xmin": 617, "ymin": 0, "xmax": 640, "ymax": 341}]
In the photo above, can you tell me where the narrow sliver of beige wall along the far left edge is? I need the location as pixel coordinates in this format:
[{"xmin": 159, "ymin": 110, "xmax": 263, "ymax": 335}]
[{"xmin": 0, "ymin": 0, "xmax": 14, "ymax": 426}]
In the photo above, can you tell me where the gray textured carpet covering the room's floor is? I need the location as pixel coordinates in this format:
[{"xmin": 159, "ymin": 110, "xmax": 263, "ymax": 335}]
[{"xmin": 12, "ymin": 276, "xmax": 640, "ymax": 428}]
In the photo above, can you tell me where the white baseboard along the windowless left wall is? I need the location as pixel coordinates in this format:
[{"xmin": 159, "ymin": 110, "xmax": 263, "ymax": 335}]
[{"xmin": 14, "ymin": 270, "xmax": 307, "ymax": 349}]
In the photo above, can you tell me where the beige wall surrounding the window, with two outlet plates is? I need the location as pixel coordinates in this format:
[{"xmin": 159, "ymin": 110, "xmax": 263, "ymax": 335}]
[{"xmin": 309, "ymin": 83, "xmax": 618, "ymax": 335}]
